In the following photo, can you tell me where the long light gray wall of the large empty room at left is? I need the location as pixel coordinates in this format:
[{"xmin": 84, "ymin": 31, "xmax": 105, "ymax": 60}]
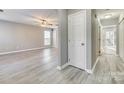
[{"xmin": 0, "ymin": 21, "xmax": 43, "ymax": 53}]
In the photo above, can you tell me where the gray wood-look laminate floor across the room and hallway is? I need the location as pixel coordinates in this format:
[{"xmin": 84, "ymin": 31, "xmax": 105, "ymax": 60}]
[{"xmin": 0, "ymin": 48, "xmax": 124, "ymax": 84}]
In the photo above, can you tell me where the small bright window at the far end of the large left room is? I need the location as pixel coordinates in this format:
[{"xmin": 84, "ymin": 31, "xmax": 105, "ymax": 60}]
[{"xmin": 44, "ymin": 31, "xmax": 51, "ymax": 46}]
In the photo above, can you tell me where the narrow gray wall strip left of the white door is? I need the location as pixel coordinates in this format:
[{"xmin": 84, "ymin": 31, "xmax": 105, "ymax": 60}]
[{"xmin": 58, "ymin": 9, "xmax": 68, "ymax": 66}]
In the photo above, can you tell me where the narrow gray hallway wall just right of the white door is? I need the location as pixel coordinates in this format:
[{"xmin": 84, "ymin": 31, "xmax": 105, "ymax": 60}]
[{"xmin": 91, "ymin": 9, "xmax": 100, "ymax": 67}]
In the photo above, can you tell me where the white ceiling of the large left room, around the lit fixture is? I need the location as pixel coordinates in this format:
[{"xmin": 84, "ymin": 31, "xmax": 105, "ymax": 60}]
[{"xmin": 0, "ymin": 9, "xmax": 58, "ymax": 26}]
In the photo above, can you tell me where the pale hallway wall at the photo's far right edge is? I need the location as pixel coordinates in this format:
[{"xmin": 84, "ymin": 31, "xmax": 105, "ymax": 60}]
[{"xmin": 119, "ymin": 14, "xmax": 124, "ymax": 61}]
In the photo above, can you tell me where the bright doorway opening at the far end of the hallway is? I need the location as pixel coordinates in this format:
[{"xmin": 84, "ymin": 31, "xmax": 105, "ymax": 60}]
[{"xmin": 100, "ymin": 26, "xmax": 117, "ymax": 55}]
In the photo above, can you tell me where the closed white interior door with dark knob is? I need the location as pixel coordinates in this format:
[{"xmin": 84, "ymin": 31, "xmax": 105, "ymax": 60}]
[{"xmin": 68, "ymin": 11, "xmax": 86, "ymax": 69}]
